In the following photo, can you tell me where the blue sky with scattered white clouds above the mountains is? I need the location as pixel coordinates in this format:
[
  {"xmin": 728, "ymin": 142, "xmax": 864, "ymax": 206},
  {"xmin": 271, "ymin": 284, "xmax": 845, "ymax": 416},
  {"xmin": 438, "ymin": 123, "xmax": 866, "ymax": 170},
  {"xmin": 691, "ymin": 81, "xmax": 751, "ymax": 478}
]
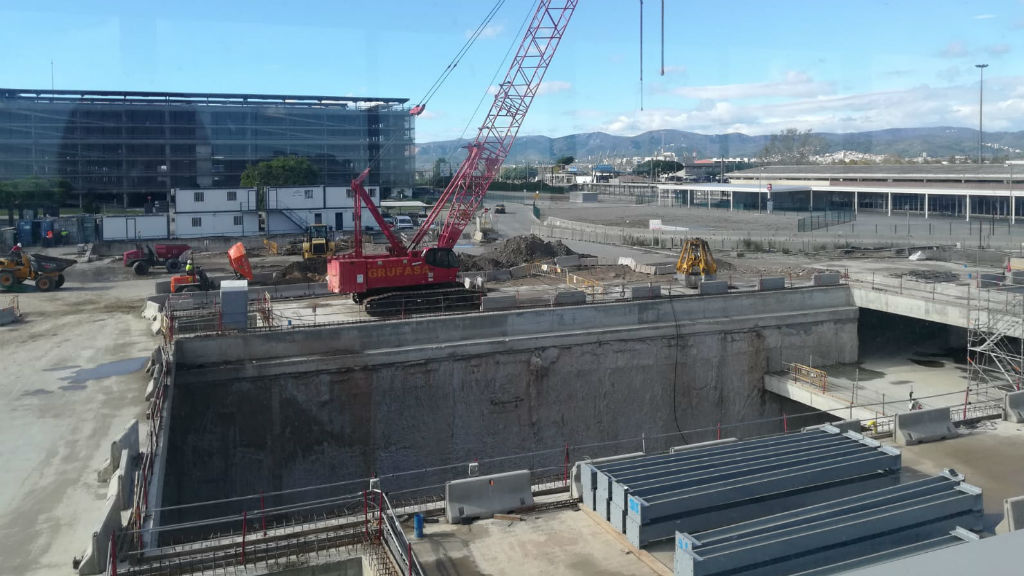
[{"xmin": 0, "ymin": 0, "xmax": 1024, "ymax": 141}]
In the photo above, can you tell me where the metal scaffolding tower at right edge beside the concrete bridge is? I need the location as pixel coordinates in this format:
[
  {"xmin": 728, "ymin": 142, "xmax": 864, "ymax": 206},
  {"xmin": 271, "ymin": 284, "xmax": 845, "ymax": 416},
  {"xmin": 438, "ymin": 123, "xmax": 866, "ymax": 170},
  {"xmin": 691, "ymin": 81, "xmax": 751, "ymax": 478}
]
[{"xmin": 967, "ymin": 277, "xmax": 1024, "ymax": 393}]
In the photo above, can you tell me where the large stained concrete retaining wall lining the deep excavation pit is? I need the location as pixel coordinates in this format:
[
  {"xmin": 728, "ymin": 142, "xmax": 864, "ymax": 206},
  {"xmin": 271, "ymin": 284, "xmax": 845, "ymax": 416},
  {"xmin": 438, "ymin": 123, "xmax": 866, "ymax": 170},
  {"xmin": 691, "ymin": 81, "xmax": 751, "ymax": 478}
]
[{"xmin": 163, "ymin": 288, "xmax": 857, "ymax": 522}]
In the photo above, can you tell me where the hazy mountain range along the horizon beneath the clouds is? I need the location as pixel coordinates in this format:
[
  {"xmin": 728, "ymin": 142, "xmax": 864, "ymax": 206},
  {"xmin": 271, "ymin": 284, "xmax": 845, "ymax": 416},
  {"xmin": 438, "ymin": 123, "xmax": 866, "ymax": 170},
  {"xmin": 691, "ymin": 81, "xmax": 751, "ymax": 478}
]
[{"xmin": 416, "ymin": 126, "xmax": 1024, "ymax": 169}]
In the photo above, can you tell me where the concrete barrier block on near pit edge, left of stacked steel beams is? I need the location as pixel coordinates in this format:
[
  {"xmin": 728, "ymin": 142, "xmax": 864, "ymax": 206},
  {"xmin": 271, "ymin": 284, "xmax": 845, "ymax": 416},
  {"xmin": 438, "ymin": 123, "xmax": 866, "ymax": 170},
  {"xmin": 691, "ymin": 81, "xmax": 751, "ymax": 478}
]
[{"xmin": 444, "ymin": 470, "xmax": 534, "ymax": 524}]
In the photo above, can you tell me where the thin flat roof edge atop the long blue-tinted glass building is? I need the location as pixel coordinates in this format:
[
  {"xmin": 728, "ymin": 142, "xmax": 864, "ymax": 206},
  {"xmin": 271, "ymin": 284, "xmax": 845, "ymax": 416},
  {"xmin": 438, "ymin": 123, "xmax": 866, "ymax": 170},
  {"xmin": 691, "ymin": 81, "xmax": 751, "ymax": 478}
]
[{"xmin": 0, "ymin": 88, "xmax": 409, "ymax": 108}]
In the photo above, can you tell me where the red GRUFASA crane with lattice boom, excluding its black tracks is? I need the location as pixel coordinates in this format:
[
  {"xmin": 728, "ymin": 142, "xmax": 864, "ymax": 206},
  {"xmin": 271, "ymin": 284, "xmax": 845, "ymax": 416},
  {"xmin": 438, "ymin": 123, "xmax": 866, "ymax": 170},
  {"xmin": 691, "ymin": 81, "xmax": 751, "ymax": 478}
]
[{"xmin": 328, "ymin": 0, "xmax": 579, "ymax": 301}]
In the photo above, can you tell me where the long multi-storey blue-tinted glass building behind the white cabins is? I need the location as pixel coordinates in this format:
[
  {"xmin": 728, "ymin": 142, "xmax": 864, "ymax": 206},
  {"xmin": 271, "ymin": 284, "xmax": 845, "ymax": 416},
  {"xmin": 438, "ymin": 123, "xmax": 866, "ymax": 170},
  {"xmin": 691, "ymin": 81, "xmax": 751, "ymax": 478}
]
[{"xmin": 0, "ymin": 88, "xmax": 416, "ymax": 205}]
